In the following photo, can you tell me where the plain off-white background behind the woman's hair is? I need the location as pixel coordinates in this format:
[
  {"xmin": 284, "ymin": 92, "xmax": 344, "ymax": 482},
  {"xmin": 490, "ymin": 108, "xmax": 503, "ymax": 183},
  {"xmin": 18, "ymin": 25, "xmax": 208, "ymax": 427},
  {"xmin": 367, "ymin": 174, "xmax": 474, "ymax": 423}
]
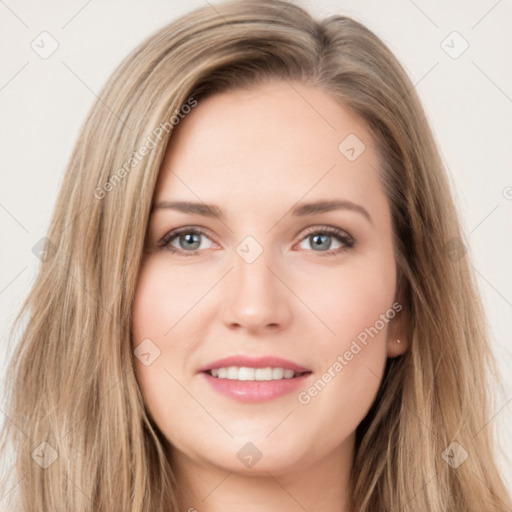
[{"xmin": 0, "ymin": 0, "xmax": 512, "ymax": 489}]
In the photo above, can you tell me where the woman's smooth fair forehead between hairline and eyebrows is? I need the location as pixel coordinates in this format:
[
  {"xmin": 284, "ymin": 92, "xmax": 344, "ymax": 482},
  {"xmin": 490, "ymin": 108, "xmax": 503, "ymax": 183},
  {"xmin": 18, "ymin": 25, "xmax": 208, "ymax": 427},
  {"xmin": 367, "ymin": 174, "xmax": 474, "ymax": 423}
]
[{"xmin": 155, "ymin": 81, "xmax": 382, "ymax": 213}]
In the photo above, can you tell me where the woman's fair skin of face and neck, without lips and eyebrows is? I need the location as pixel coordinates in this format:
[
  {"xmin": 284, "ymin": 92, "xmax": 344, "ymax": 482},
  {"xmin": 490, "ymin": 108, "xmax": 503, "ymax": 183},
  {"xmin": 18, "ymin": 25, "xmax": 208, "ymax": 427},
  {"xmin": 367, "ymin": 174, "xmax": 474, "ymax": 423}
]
[{"xmin": 133, "ymin": 81, "xmax": 407, "ymax": 512}]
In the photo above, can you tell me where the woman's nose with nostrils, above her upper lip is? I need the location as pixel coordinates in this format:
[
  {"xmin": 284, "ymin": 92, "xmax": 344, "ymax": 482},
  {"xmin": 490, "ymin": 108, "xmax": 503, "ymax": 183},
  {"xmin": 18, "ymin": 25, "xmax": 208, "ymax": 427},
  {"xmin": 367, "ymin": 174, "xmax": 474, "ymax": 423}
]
[{"xmin": 222, "ymin": 246, "xmax": 292, "ymax": 333}]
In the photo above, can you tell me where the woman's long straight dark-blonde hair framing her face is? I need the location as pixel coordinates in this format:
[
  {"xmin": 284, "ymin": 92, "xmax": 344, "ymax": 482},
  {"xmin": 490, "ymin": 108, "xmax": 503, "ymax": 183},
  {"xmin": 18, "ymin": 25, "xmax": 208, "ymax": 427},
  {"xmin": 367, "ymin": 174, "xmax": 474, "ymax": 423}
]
[{"xmin": 1, "ymin": 0, "xmax": 511, "ymax": 512}]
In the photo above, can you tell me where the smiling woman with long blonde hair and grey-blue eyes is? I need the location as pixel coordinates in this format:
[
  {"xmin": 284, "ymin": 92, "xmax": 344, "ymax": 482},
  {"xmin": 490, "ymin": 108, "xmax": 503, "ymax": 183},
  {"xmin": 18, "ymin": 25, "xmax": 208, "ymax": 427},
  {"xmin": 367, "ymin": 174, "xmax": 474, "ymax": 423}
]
[{"xmin": 3, "ymin": 1, "xmax": 510, "ymax": 512}]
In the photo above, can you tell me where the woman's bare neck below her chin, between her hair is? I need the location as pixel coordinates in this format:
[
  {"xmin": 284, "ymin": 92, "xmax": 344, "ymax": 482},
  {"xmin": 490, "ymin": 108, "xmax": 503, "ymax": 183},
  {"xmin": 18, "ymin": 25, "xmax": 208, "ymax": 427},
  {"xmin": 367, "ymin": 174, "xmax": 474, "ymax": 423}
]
[{"xmin": 172, "ymin": 436, "xmax": 354, "ymax": 512}]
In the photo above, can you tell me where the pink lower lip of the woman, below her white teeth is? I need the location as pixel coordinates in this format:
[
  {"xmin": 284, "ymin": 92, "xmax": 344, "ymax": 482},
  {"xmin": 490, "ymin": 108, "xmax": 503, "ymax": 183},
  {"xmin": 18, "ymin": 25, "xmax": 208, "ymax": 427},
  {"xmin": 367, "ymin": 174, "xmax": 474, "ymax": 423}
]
[{"xmin": 202, "ymin": 372, "xmax": 311, "ymax": 403}]
